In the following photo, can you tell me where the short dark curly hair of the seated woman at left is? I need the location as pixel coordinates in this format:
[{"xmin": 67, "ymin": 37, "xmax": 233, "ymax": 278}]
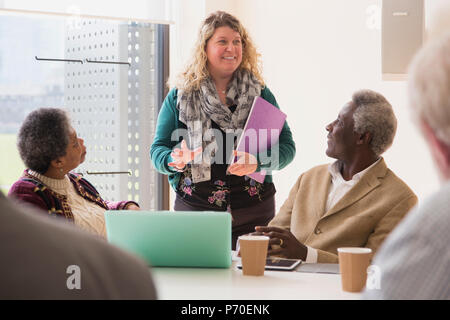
[{"xmin": 17, "ymin": 108, "xmax": 71, "ymax": 174}]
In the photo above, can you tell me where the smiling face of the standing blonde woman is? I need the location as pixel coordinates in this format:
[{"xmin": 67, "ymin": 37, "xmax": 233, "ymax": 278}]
[{"xmin": 206, "ymin": 26, "xmax": 242, "ymax": 78}]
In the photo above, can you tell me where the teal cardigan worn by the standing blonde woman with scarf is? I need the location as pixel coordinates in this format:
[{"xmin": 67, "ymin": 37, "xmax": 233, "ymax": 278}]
[{"xmin": 150, "ymin": 87, "xmax": 295, "ymax": 190}]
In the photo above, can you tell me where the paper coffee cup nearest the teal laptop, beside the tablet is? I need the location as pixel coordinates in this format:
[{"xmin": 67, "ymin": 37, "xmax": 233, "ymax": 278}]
[{"xmin": 239, "ymin": 236, "xmax": 269, "ymax": 276}]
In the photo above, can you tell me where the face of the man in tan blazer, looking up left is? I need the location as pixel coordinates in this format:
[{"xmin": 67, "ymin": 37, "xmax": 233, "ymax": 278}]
[{"xmin": 325, "ymin": 102, "xmax": 358, "ymax": 160}]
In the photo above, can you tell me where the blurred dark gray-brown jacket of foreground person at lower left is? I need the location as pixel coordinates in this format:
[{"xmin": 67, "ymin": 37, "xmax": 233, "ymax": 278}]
[{"xmin": 0, "ymin": 192, "xmax": 156, "ymax": 299}]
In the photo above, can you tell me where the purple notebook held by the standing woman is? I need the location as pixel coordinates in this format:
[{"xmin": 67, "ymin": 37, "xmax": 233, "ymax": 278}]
[{"xmin": 229, "ymin": 97, "xmax": 286, "ymax": 183}]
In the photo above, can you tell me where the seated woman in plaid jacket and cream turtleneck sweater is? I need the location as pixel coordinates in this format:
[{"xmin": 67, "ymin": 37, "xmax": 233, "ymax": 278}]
[{"xmin": 9, "ymin": 108, "xmax": 139, "ymax": 237}]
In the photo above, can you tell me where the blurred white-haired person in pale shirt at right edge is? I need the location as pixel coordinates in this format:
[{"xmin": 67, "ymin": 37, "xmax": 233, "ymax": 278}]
[{"xmin": 363, "ymin": 33, "xmax": 450, "ymax": 299}]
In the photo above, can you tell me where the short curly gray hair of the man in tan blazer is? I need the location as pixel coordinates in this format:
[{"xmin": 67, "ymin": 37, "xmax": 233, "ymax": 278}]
[{"xmin": 352, "ymin": 89, "xmax": 397, "ymax": 156}]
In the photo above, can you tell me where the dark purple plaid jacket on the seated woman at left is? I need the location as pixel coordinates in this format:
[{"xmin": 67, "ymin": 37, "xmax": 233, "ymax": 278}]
[{"xmin": 8, "ymin": 170, "xmax": 138, "ymax": 222}]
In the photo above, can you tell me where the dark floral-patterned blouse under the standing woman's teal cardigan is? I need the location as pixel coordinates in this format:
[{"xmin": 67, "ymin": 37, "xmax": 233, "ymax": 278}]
[{"xmin": 176, "ymin": 106, "xmax": 276, "ymax": 212}]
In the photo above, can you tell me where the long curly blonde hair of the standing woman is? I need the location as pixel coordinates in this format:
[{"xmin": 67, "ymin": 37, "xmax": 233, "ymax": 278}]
[{"xmin": 175, "ymin": 11, "xmax": 264, "ymax": 92}]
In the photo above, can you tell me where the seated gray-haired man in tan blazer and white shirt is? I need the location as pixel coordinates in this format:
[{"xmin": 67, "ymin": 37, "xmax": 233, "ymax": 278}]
[{"xmin": 255, "ymin": 90, "xmax": 417, "ymax": 263}]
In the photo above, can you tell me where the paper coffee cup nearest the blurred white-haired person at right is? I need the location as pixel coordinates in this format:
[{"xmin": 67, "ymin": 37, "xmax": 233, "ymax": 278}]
[{"xmin": 338, "ymin": 247, "xmax": 372, "ymax": 292}]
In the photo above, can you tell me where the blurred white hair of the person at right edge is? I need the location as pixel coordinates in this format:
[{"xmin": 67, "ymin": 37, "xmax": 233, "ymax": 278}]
[{"xmin": 408, "ymin": 33, "xmax": 450, "ymax": 145}]
